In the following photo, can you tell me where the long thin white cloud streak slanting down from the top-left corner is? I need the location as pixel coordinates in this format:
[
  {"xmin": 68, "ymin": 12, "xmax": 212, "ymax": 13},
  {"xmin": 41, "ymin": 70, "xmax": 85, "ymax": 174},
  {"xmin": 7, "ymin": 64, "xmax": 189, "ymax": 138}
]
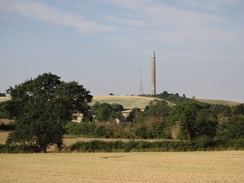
[{"xmin": 0, "ymin": 0, "xmax": 115, "ymax": 33}]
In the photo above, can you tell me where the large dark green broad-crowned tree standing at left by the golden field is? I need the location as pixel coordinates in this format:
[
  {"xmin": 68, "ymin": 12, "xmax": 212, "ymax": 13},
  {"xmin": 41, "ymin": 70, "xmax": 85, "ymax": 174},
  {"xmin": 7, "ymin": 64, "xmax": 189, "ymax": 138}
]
[{"xmin": 6, "ymin": 73, "xmax": 92, "ymax": 152}]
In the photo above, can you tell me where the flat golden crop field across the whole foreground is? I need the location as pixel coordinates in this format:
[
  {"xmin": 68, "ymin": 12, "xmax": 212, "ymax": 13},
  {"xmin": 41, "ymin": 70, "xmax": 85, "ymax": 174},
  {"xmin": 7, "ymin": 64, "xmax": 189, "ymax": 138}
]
[{"xmin": 0, "ymin": 151, "xmax": 244, "ymax": 183}]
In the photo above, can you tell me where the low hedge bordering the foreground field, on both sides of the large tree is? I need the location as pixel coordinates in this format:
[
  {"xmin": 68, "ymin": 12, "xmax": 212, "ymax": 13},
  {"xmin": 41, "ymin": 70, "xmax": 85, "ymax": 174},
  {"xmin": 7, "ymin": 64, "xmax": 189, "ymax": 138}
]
[{"xmin": 0, "ymin": 139, "xmax": 244, "ymax": 153}]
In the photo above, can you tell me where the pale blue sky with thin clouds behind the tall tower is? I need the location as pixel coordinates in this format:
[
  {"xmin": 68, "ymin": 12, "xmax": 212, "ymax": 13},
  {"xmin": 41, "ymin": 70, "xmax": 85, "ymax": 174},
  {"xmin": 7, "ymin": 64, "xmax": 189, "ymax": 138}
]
[{"xmin": 0, "ymin": 0, "xmax": 244, "ymax": 103}]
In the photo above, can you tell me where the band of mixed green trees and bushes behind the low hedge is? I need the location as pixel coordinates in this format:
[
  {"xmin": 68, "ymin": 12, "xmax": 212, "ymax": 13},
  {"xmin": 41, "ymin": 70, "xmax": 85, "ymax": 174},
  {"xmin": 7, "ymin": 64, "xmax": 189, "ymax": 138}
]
[{"xmin": 66, "ymin": 100, "xmax": 244, "ymax": 147}]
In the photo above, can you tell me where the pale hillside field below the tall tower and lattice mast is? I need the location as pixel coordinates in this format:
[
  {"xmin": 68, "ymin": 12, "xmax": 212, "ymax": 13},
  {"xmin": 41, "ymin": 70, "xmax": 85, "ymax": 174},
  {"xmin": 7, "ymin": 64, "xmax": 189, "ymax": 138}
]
[{"xmin": 91, "ymin": 95, "xmax": 172, "ymax": 109}]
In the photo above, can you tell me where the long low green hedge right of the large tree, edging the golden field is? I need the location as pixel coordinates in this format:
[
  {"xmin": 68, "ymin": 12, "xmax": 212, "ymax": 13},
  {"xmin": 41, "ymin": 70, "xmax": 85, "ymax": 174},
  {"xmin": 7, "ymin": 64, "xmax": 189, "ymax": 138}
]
[{"xmin": 71, "ymin": 139, "xmax": 244, "ymax": 152}]
